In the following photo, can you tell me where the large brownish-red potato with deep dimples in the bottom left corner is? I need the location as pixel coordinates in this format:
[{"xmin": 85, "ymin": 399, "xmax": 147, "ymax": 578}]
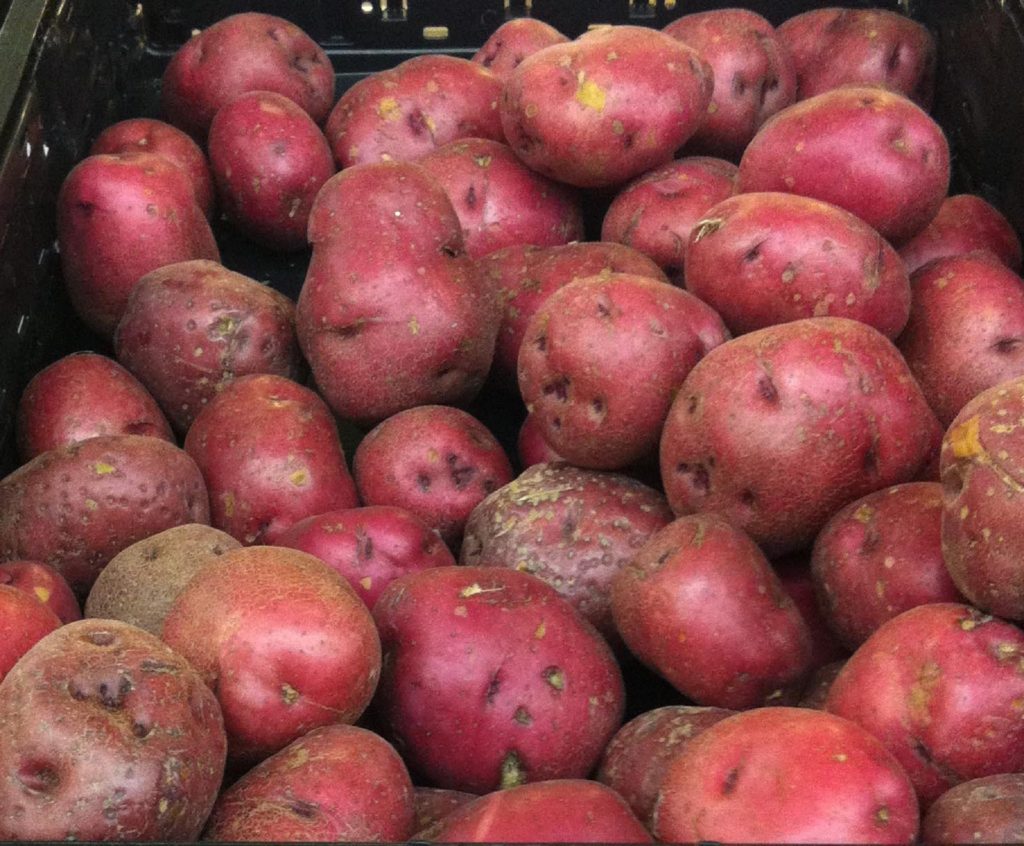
[{"xmin": 0, "ymin": 620, "xmax": 225, "ymax": 843}]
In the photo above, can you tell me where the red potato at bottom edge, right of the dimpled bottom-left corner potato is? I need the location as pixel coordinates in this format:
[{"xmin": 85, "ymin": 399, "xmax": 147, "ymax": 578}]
[{"xmin": 203, "ymin": 725, "xmax": 416, "ymax": 843}]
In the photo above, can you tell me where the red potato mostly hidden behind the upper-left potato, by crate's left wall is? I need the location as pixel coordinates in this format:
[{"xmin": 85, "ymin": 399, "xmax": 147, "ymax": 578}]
[{"xmin": 89, "ymin": 118, "xmax": 214, "ymax": 218}]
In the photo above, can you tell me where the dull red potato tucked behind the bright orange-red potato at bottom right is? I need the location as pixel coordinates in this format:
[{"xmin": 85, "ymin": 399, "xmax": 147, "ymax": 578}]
[{"xmin": 595, "ymin": 705, "xmax": 736, "ymax": 830}]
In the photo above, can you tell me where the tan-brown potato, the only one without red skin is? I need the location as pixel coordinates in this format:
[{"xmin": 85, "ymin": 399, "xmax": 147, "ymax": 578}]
[{"xmin": 85, "ymin": 523, "xmax": 242, "ymax": 637}]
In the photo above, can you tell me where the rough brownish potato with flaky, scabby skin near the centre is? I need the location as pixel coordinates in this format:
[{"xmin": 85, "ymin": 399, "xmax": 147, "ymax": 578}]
[{"xmin": 460, "ymin": 464, "xmax": 672, "ymax": 644}]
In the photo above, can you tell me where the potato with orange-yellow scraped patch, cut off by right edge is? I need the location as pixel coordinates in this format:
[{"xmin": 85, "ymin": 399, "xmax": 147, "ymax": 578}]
[{"xmin": 939, "ymin": 377, "xmax": 1024, "ymax": 621}]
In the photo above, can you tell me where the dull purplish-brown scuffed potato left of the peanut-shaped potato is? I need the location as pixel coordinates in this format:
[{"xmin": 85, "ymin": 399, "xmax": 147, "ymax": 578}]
[{"xmin": 114, "ymin": 261, "xmax": 303, "ymax": 433}]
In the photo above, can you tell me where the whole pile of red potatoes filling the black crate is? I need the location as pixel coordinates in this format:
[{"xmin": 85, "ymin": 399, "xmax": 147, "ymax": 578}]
[{"xmin": 6, "ymin": 8, "xmax": 1024, "ymax": 843}]
